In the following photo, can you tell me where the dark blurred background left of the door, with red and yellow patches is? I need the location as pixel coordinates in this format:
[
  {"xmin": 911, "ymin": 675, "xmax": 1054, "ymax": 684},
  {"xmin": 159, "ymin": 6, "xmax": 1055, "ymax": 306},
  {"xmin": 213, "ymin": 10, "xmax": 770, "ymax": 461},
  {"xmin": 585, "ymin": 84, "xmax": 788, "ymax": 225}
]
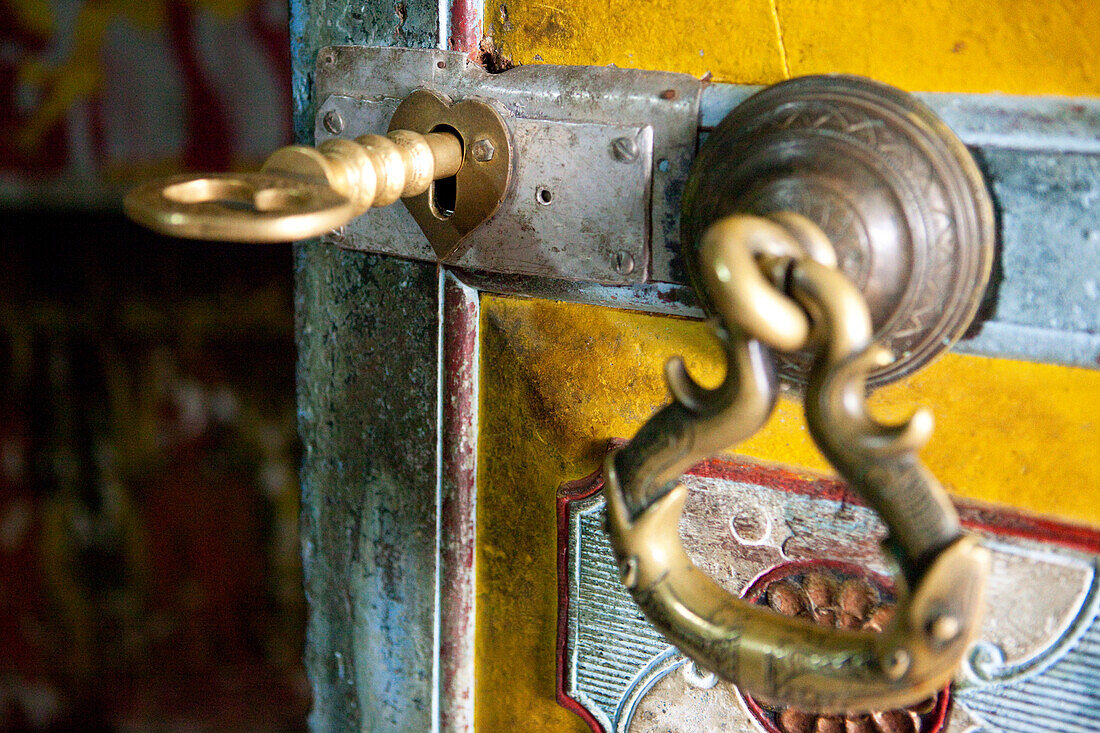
[{"xmin": 0, "ymin": 0, "xmax": 309, "ymax": 732}]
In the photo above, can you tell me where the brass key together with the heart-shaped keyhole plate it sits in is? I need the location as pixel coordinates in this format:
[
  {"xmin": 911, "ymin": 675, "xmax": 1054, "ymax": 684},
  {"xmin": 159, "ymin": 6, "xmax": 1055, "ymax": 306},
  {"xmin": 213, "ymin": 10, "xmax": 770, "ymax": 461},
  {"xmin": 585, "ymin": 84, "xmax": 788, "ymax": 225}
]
[{"xmin": 124, "ymin": 90, "xmax": 512, "ymax": 248}]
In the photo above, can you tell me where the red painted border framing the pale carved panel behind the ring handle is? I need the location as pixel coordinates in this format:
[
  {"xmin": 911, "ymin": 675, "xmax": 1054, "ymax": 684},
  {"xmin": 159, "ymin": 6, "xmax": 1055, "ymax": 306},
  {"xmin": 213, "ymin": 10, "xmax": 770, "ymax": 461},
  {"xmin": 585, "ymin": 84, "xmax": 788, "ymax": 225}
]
[{"xmin": 557, "ymin": 449, "xmax": 1100, "ymax": 733}]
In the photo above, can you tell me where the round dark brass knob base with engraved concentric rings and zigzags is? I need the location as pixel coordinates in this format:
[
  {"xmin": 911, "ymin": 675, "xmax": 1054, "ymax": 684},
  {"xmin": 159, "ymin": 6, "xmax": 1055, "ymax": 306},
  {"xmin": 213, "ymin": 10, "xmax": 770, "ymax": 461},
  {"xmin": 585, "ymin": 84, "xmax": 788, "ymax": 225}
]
[{"xmin": 683, "ymin": 75, "xmax": 994, "ymax": 386}]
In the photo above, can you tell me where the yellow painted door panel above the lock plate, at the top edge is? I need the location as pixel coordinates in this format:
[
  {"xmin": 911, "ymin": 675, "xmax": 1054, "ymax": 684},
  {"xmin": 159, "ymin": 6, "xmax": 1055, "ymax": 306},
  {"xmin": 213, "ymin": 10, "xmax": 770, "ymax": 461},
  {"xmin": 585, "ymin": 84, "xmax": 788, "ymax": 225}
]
[{"xmin": 485, "ymin": 0, "xmax": 1100, "ymax": 95}]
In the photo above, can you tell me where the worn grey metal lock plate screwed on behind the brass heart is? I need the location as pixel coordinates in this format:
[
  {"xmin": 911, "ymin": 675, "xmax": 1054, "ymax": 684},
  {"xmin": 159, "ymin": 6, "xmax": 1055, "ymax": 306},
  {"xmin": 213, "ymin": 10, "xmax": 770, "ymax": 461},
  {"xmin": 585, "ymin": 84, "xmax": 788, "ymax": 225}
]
[{"xmin": 316, "ymin": 46, "xmax": 702, "ymax": 284}]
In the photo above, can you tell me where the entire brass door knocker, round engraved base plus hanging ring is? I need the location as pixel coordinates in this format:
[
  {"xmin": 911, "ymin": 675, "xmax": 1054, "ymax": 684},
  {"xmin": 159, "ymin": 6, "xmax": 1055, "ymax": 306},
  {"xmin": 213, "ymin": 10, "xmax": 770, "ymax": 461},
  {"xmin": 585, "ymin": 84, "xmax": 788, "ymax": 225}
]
[{"xmin": 604, "ymin": 77, "xmax": 993, "ymax": 712}]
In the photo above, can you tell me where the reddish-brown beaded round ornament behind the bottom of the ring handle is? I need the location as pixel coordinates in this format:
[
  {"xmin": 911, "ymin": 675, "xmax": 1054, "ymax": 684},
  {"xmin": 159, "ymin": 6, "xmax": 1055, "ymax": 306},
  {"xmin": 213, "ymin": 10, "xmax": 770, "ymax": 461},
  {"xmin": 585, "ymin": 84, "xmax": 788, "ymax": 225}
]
[{"xmin": 746, "ymin": 562, "xmax": 947, "ymax": 733}]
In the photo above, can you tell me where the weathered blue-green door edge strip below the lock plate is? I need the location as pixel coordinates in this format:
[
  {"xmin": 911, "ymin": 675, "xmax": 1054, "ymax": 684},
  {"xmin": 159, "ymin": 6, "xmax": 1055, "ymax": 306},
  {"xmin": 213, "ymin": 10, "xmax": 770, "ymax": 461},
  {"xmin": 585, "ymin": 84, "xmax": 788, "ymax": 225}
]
[{"xmin": 296, "ymin": 244, "xmax": 438, "ymax": 731}]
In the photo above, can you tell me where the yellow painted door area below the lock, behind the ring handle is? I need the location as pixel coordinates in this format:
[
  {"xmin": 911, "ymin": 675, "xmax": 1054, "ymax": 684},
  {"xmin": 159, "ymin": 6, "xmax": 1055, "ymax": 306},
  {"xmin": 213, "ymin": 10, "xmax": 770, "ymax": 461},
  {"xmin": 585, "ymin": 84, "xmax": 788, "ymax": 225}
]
[{"xmin": 476, "ymin": 295, "xmax": 1100, "ymax": 731}]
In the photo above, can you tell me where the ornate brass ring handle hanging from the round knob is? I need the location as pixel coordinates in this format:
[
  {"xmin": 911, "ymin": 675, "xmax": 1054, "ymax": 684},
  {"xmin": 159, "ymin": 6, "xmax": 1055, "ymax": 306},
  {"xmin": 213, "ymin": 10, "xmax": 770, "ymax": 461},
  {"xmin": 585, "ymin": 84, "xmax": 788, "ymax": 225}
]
[{"xmin": 604, "ymin": 216, "xmax": 989, "ymax": 712}]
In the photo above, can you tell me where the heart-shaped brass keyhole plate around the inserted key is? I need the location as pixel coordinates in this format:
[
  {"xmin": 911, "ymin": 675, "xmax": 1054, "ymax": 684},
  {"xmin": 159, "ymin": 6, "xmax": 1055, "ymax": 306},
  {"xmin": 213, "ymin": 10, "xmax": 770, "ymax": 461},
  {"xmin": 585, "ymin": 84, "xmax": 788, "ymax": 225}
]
[{"xmin": 389, "ymin": 89, "xmax": 512, "ymax": 262}]
